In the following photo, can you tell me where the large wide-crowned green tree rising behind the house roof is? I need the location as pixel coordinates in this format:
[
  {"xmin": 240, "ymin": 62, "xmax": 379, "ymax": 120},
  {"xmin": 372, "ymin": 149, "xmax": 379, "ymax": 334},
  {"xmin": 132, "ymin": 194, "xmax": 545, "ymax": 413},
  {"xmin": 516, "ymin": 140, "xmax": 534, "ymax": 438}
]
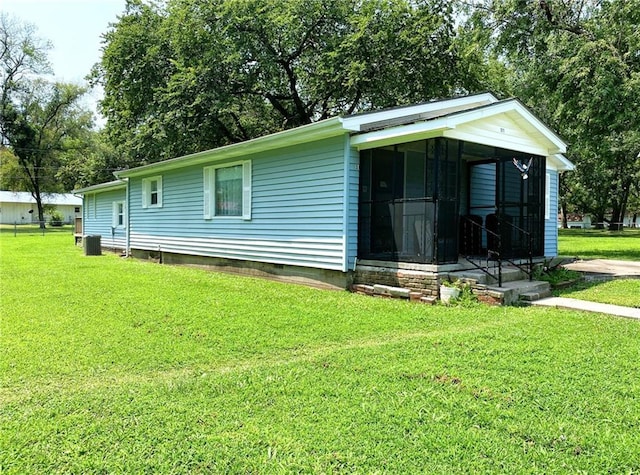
[{"xmin": 93, "ymin": 0, "xmax": 478, "ymax": 165}]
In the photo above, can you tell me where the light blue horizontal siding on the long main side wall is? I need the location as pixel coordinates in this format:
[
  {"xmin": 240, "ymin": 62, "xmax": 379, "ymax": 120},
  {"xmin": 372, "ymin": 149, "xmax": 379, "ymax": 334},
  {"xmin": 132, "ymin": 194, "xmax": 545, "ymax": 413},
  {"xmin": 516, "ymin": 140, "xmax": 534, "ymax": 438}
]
[{"xmin": 129, "ymin": 137, "xmax": 350, "ymax": 270}]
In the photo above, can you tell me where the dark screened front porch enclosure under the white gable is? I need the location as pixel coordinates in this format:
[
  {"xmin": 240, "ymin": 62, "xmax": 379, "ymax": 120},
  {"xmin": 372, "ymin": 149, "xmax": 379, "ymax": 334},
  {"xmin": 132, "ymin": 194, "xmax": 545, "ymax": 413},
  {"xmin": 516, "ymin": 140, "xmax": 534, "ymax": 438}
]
[{"xmin": 358, "ymin": 137, "xmax": 545, "ymax": 264}]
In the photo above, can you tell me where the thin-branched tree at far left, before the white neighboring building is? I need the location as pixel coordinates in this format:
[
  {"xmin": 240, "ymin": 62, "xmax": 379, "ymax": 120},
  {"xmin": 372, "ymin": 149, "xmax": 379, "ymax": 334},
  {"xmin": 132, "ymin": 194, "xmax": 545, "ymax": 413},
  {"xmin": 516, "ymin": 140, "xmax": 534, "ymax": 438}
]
[{"xmin": 0, "ymin": 15, "xmax": 92, "ymax": 227}]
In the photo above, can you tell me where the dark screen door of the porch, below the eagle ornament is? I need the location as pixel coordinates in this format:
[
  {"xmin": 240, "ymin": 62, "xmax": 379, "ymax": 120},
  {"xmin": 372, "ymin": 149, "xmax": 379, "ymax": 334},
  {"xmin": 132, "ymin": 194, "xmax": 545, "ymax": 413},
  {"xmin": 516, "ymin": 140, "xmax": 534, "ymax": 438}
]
[{"xmin": 496, "ymin": 150, "xmax": 546, "ymax": 258}]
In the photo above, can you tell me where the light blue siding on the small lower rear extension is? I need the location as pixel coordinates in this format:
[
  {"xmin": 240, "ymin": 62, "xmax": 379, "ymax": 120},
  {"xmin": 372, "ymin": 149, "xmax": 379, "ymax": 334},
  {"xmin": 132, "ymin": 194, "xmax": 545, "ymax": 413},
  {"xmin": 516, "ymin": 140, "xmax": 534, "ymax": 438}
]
[{"xmin": 82, "ymin": 188, "xmax": 126, "ymax": 249}]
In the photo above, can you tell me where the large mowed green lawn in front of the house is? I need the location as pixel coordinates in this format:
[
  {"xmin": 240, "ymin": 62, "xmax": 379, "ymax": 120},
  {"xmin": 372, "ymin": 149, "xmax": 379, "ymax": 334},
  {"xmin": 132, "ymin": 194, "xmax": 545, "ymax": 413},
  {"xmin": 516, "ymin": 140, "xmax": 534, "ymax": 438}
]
[{"xmin": 0, "ymin": 232, "xmax": 640, "ymax": 474}]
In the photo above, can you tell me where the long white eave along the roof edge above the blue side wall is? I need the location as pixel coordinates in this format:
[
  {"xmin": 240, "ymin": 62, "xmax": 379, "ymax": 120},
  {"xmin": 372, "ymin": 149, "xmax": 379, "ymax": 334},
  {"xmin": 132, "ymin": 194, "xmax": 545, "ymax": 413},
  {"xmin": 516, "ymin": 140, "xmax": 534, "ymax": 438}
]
[{"xmin": 114, "ymin": 117, "xmax": 346, "ymax": 178}]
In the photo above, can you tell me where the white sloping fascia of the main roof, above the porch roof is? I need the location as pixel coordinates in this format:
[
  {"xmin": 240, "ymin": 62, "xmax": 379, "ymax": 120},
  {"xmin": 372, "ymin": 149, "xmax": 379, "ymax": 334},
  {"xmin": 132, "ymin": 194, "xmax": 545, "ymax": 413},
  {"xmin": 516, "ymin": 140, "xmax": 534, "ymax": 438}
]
[{"xmin": 342, "ymin": 92, "xmax": 498, "ymax": 132}]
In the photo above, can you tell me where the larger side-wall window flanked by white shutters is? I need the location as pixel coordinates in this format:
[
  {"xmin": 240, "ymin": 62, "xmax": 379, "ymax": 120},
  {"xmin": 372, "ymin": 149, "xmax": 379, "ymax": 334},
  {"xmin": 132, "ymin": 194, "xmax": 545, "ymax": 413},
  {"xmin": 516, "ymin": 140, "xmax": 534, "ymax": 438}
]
[{"xmin": 203, "ymin": 160, "xmax": 251, "ymax": 219}]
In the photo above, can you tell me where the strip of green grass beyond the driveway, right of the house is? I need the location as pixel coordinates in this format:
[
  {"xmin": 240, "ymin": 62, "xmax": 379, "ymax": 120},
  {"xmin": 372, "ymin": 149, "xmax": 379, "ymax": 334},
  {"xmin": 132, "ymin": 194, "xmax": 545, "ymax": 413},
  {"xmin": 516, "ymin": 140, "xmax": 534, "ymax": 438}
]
[{"xmin": 558, "ymin": 229, "xmax": 640, "ymax": 261}]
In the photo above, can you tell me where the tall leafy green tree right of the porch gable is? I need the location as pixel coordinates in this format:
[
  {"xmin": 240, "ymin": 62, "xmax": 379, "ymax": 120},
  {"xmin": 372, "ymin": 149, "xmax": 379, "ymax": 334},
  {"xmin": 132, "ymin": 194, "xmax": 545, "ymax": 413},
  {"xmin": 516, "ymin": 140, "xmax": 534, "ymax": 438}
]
[{"xmin": 464, "ymin": 0, "xmax": 640, "ymax": 229}]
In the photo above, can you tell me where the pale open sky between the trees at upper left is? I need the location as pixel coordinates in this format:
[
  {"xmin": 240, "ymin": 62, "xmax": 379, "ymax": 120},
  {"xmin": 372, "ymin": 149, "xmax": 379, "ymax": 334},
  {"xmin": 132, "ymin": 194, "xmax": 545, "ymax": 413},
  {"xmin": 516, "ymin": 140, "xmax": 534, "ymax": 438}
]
[{"xmin": 0, "ymin": 0, "xmax": 125, "ymax": 123}]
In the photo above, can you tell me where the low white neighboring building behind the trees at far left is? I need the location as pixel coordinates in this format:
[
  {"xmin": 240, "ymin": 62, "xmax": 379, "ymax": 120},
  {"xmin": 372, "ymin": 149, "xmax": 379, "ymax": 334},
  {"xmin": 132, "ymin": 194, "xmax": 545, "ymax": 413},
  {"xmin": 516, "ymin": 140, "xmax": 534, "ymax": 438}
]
[{"xmin": 0, "ymin": 191, "xmax": 82, "ymax": 224}]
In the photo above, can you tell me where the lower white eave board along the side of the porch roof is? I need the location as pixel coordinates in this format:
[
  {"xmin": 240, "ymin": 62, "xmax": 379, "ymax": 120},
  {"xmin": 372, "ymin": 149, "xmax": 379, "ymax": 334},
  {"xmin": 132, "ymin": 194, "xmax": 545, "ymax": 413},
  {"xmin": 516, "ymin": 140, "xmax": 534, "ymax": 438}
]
[{"xmin": 351, "ymin": 118, "xmax": 451, "ymax": 150}]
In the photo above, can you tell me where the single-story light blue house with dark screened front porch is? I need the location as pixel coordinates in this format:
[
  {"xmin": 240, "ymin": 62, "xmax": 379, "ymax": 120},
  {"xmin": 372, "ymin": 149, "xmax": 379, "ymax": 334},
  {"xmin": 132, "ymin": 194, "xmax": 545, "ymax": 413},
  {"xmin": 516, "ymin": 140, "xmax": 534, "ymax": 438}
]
[{"xmin": 76, "ymin": 93, "xmax": 573, "ymax": 298}]
